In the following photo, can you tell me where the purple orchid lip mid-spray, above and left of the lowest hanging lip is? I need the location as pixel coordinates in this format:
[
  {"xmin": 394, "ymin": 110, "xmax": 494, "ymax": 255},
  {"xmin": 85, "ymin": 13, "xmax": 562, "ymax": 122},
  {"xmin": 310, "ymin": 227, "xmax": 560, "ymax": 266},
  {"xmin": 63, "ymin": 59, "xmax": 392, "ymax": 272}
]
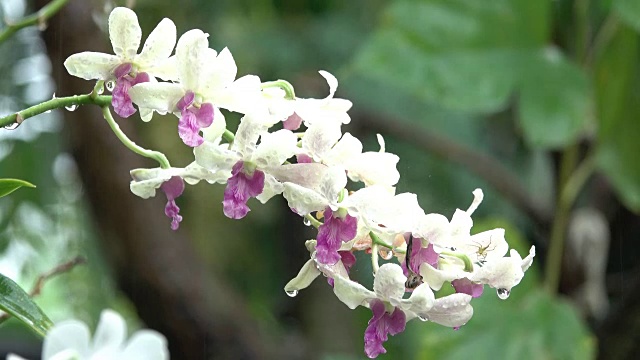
[{"xmin": 316, "ymin": 207, "xmax": 358, "ymax": 265}]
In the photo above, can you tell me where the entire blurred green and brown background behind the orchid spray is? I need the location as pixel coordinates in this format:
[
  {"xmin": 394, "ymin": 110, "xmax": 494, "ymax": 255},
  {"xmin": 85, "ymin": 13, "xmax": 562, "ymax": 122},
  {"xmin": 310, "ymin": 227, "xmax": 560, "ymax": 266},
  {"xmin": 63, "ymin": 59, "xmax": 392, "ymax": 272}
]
[{"xmin": 0, "ymin": 0, "xmax": 640, "ymax": 359}]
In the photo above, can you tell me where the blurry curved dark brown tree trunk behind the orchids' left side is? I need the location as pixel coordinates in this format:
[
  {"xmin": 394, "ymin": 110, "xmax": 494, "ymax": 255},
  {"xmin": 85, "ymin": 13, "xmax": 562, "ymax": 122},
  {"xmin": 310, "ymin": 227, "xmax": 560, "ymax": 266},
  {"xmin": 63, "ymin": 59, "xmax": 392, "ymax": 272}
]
[{"xmin": 36, "ymin": 0, "xmax": 282, "ymax": 359}]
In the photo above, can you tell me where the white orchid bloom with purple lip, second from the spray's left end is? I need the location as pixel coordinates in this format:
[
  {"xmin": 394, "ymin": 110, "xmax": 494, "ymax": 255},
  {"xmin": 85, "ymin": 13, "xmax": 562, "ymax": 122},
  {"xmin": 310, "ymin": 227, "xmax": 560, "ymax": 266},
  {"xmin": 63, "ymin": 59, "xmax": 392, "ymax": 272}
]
[{"xmin": 130, "ymin": 29, "xmax": 266, "ymax": 147}]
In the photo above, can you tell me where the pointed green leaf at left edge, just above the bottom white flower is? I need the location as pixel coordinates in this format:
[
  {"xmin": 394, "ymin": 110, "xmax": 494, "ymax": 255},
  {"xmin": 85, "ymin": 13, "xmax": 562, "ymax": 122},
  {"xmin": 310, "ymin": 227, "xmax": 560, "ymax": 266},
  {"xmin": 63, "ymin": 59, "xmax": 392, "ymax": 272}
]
[{"xmin": 0, "ymin": 274, "xmax": 53, "ymax": 336}]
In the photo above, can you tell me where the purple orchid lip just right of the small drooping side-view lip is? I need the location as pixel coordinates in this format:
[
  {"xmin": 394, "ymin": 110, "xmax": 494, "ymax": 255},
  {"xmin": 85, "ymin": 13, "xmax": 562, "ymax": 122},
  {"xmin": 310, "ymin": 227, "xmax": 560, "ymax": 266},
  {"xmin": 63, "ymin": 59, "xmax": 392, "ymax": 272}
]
[{"xmin": 222, "ymin": 160, "xmax": 264, "ymax": 219}]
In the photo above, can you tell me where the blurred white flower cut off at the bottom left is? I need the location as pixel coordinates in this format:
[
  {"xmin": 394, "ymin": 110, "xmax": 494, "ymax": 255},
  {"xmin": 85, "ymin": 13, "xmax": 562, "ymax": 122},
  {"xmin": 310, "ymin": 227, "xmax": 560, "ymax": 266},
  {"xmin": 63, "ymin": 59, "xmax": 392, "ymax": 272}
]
[{"xmin": 7, "ymin": 310, "xmax": 169, "ymax": 360}]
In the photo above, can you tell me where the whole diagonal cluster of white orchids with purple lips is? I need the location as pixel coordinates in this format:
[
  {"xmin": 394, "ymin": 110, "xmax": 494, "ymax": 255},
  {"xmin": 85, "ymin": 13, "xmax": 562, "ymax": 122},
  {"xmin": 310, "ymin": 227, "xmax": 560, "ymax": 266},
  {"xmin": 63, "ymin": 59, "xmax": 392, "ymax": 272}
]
[{"xmin": 65, "ymin": 8, "xmax": 535, "ymax": 358}]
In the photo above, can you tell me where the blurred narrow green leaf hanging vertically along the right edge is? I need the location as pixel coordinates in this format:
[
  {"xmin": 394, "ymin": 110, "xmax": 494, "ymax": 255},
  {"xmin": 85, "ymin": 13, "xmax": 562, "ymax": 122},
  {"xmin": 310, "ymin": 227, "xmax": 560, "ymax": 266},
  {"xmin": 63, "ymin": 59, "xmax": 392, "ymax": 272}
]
[{"xmin": 595, "ymin": 27, "xmax": 640, "ymax": 211}]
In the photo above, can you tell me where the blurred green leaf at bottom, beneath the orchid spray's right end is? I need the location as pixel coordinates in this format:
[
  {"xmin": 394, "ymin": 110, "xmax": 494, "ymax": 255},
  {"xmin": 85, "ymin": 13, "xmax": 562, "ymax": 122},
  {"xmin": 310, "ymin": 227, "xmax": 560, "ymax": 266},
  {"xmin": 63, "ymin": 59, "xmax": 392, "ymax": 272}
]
[{"xmin": 417, "ymin": 290, "xmax": 595, "ymax": 360}]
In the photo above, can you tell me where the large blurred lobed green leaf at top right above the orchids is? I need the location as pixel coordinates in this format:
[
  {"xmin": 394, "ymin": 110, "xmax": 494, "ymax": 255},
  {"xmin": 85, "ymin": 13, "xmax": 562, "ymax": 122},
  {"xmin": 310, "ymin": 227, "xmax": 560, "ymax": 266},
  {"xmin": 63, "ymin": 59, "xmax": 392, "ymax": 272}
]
[{"xmin": 355, "ymin": 0, "xmax": 589, "ymax": 148}]
